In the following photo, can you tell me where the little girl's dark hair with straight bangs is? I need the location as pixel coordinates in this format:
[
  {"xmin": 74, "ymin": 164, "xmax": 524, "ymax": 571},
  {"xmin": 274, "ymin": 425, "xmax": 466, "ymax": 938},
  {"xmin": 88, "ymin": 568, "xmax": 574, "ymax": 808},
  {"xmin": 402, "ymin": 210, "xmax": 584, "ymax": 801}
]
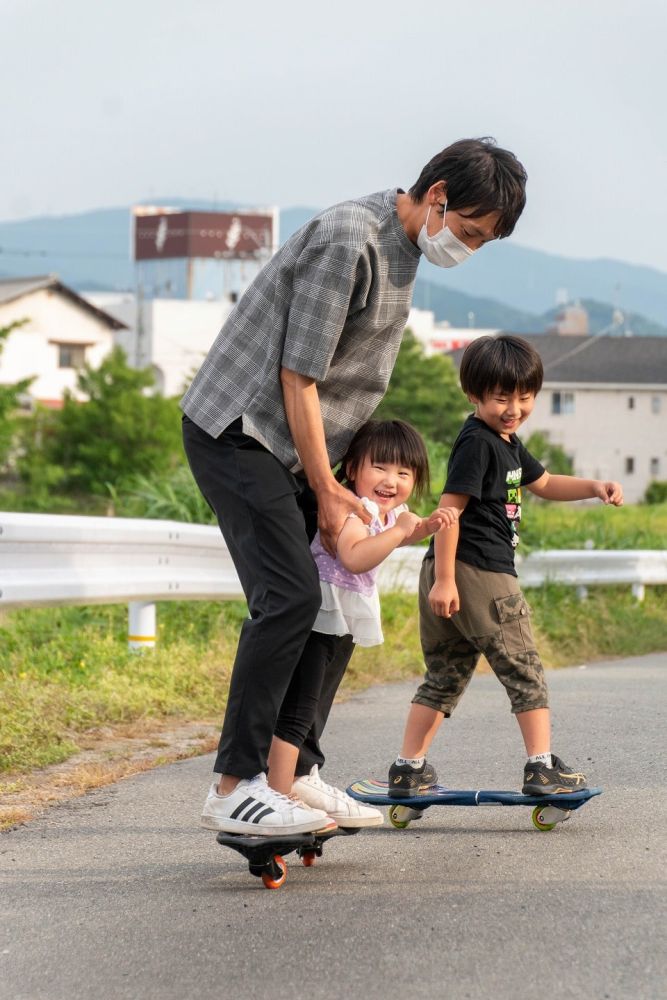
[{"xmin": 336, "ymin": 420, "xmax": 430, "ymax": 497}]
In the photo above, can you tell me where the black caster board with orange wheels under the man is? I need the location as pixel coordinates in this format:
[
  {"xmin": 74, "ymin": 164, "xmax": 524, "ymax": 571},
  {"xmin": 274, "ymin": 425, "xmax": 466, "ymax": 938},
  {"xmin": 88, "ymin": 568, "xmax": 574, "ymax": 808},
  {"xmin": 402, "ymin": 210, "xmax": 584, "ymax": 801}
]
[{"xmin": 216, "ymin": 826, "xmax": 359, "ymax": 889}]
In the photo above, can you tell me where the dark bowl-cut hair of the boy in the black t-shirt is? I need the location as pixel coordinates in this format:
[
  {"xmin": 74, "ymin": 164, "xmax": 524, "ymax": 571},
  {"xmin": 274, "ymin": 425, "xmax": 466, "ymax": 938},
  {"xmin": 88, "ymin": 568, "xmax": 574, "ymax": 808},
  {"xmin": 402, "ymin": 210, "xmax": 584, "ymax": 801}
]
[{"xmin": 459, "ymin": 333, "xmax": 544, "ymax": 400}]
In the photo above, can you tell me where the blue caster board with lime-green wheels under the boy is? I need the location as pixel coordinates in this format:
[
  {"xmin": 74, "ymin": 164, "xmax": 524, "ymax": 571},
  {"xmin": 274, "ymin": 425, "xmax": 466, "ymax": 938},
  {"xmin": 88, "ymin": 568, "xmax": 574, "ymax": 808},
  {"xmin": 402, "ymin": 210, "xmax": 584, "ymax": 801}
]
[{"xmin": 347, "ymin": 778, "xmax": 602, "ymax": 830}]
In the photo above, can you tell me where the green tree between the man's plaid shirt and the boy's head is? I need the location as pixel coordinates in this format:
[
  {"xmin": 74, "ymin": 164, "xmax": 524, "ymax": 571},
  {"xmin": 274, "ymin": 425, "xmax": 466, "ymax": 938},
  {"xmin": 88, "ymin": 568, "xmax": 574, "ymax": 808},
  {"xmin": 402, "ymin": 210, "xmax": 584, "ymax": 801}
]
[{"xmin": 374, "ymin": 329, "xmax": 470, "ymax": 449}]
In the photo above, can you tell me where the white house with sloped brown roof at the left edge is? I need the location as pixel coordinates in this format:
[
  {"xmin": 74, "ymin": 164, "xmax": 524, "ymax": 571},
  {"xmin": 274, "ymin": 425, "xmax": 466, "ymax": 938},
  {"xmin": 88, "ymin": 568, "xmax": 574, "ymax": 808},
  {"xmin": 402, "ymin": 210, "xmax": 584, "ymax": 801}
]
[{"xmin": 0, "ymin": 275, "xmax": 124, "ymax": 407}]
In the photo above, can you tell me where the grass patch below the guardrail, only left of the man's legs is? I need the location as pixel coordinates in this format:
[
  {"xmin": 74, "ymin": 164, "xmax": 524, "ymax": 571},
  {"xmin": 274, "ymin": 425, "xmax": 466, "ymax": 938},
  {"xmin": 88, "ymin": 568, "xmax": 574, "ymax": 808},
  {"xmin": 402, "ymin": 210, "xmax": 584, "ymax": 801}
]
[{"xmin": 0, "ymin": 602, "xmax": 245, "ymax": 772}]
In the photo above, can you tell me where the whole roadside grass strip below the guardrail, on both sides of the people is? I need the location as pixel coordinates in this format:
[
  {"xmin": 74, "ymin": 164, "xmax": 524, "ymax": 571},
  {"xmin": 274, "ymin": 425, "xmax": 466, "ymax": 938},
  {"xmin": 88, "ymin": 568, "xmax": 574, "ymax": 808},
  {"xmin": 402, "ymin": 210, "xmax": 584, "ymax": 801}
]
[{"xmin": 0, "ymin": 585, "xmax": 667, "ymax": 791}]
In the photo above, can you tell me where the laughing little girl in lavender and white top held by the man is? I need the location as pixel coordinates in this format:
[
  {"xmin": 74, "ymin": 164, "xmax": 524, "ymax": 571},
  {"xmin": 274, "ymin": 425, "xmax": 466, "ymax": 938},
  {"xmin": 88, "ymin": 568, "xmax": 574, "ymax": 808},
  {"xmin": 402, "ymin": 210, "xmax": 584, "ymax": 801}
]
[{"xmin": 269, "ymin": 420, "xmax": 458, "ymax": 826}]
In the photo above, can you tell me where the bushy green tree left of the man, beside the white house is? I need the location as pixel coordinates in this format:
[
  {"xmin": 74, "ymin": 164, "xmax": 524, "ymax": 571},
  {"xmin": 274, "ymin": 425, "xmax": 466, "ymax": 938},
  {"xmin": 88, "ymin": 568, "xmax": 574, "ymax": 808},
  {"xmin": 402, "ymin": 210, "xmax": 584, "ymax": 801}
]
[{"xmin": 20, "ymin": 348, "xmax": 183, "ymax": 494}]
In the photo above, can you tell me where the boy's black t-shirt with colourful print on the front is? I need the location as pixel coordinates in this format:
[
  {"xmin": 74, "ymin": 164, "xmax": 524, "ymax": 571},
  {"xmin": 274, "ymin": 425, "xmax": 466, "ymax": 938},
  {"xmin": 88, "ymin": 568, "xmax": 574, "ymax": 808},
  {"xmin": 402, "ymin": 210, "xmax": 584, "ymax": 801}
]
[{"xmin": 429, "ymin": 415, "xmax": 544, "ymax": 576}]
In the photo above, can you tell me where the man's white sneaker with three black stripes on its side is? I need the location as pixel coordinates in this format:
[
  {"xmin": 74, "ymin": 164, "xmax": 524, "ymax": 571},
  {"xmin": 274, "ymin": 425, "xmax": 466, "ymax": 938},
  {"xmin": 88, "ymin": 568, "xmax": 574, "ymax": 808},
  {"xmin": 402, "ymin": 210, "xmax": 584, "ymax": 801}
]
[{"xmin": 201, "ymin": 774, "xmax": 334, "ymax": 837}]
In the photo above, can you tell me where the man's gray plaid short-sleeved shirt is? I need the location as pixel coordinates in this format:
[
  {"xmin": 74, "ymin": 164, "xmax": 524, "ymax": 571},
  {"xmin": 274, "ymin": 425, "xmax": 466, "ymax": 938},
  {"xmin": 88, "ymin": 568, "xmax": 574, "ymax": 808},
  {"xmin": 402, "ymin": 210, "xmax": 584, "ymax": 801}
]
[{"xmin": 181, "ymin": 188, "xmax": 421, "ymax": 469}]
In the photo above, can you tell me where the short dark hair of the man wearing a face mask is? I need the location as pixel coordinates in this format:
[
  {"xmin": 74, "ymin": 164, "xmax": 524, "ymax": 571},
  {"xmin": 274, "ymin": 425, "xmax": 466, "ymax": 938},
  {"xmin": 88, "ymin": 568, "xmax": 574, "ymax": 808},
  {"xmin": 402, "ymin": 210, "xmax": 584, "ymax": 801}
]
[{"xmin": 410, "ymin": 136, "xmax": 528, "ymax": 240}]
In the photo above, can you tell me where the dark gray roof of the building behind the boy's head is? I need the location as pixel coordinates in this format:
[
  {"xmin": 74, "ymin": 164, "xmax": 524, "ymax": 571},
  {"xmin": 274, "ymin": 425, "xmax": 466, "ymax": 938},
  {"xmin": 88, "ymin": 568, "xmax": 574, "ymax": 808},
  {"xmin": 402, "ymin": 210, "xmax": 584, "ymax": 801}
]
[{"xmin": 451, "ymin": 333, "xmax": 667, "ymax": 385}]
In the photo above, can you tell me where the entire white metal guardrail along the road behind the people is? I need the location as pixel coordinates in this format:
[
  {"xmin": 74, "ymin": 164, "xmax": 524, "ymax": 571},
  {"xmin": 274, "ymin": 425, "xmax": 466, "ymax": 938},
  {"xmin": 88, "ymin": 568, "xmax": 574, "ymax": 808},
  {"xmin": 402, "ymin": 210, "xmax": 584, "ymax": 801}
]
[{"xmin": 0, "ymin": 512, "xmax": 667, "ymax": 648}]
